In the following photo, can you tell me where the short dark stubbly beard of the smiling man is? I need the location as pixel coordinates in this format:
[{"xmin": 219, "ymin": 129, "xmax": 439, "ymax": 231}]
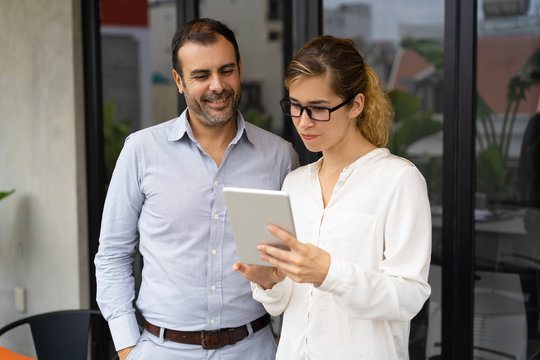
[{"xmin": 184, "ymin": 89, "xmax": 240, "ymax": 127}]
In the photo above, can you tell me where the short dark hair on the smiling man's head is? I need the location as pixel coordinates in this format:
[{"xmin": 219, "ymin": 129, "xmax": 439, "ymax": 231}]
[{"xmin": 171, "ymin": 18, "xmax": 240, "ymax": 78}]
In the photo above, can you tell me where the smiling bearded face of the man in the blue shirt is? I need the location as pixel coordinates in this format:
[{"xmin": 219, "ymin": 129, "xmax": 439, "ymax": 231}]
[{"xmin": 173, "ymin": 35, "xmax": 241, "ymax": 127}]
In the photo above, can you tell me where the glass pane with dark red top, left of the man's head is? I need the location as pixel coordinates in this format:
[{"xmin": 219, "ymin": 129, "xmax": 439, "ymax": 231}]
[{"xmin": 100, "ymin": 0, "xmax": 178, "ymax": 182}]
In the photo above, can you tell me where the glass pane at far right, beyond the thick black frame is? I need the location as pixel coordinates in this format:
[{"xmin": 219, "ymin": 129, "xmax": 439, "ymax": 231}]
[{"xmin": 474, "ymin": 0, "xmax": 540, "ymax": 359}]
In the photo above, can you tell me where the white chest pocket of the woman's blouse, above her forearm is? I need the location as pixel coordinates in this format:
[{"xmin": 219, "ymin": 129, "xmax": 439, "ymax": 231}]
[{"xmin": 320, "ymin": 212, "xmax": 376, "ymax": 269}]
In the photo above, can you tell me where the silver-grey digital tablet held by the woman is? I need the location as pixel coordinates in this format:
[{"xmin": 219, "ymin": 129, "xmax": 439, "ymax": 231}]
[{"xmin": 223, "ymin": 187, "xmax": 296, "ymax": 266}]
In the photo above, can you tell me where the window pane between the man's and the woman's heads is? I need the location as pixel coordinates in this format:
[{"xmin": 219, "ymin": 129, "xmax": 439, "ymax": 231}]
[{"xmin": 199, "ymin": 0, "xmax": 283, "ymax": 133}]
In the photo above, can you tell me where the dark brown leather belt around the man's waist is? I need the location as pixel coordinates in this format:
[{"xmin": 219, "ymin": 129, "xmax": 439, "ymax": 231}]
[{"xmin": 145, "ymin": 314, "xmax": 270, "ymax": 349}]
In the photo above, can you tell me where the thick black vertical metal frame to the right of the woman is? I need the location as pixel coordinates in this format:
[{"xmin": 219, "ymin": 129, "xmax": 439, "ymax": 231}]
[{"xmin": 441, "ymin": 0, "xmax": 477, "ymax": 360}]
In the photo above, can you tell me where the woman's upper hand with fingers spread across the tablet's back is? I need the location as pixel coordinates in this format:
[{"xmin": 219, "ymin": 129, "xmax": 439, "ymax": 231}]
[{"xmin": 257, "ymin": 225, "xmax": 331, "ymax": 286}]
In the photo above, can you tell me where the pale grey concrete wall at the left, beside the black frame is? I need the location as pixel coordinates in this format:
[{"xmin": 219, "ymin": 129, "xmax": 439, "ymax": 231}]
[{"xmin": 0, "ymin": 0, "xmax": 89, "ymax": 355}]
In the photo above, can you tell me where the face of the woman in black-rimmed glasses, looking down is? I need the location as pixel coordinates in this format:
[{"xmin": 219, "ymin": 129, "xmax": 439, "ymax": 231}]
[{"xmin": 289, "ymin": 75, "xmax": 363, "ymax": 152}]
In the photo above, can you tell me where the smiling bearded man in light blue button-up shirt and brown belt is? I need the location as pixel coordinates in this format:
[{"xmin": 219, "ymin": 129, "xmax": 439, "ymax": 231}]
[{"xmin": 95, "ymin": 19, "xmax": 298, "ymax": 360}]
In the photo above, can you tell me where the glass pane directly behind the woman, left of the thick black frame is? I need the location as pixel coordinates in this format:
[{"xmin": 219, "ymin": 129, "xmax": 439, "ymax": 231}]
[{"xmin": 323, "ymin": 0, "xmax": 444, "ymax": 359}]
